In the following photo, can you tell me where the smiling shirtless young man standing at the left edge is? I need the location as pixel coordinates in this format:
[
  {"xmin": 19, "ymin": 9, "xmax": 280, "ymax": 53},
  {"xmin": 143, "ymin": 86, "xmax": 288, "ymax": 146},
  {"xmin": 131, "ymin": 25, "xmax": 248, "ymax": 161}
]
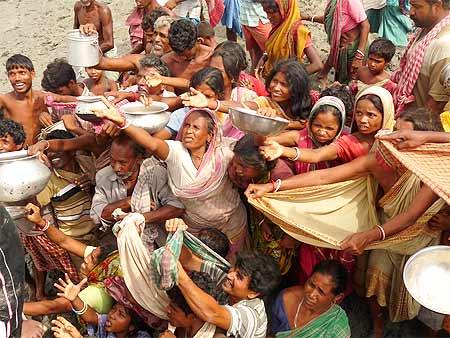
[{"xmin": 0, "ymin": 54, "xmax": 47, "ymax": 146}]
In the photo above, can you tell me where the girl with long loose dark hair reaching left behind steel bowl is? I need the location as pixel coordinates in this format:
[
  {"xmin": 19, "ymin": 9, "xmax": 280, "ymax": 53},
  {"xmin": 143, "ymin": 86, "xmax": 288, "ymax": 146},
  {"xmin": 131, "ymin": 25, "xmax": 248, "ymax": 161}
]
[{"xmin": 183, "ymin": 60, "xmax": 310, "ymax": 129}]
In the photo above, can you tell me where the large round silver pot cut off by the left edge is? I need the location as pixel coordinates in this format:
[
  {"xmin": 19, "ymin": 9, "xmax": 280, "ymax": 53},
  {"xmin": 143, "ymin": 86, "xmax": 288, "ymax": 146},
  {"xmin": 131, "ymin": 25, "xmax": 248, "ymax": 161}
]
[{"xmin": 0, "ymin": 150, "xmax": 51, "ymax": 202}]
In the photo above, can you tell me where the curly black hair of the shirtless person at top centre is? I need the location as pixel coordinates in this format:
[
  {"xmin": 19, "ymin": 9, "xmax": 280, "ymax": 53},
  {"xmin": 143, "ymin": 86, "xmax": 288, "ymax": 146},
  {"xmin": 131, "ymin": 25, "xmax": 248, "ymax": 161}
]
[{"xmin": 169, "ymin": 19, "xmax": 197, "ymax": 54}]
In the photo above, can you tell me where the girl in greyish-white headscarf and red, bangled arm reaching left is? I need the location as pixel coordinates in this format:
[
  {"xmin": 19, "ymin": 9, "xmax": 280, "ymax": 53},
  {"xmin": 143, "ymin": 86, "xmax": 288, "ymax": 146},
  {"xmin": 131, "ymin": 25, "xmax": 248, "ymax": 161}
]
[{"xmin": 260, "ymin": 96, "xmax": 345, "ymax": 174}]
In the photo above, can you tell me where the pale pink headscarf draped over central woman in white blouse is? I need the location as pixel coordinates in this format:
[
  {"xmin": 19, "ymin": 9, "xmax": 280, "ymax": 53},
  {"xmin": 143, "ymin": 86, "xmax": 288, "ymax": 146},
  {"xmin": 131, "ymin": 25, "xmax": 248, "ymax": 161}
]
[{"xmin": 172, "ymin": 109, "xmax": 227, "ymax": 198}]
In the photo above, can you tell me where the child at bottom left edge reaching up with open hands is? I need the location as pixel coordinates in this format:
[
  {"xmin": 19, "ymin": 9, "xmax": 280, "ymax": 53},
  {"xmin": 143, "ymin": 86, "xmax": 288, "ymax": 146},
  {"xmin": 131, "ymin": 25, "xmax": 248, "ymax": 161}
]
[{"xmin": 52, "ymin": 275, "xmax": 151, "ymax": 338}]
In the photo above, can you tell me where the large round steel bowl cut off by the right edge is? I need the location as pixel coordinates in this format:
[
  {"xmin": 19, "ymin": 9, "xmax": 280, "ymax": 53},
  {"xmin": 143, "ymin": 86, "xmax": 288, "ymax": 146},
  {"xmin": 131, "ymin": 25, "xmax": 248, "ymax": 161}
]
[{"xmin": 403, "ymin": 245, "xmax": 450, "ymax": 315}]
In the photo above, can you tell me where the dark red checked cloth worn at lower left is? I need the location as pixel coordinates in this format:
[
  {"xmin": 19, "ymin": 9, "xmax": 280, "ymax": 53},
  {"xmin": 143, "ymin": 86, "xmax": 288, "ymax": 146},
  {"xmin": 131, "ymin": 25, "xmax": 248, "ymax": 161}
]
[{"xmin": 19, "ymin": 231, "xmax": 79, "ymax": 283}]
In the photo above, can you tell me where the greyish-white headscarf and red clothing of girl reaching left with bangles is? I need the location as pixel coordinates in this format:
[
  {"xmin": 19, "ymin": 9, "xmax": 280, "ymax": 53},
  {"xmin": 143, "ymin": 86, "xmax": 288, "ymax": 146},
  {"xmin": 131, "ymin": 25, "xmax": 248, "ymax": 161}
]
[{"xmin": 294, "ymin": 96, "xmax": 345, "ymax": 174}]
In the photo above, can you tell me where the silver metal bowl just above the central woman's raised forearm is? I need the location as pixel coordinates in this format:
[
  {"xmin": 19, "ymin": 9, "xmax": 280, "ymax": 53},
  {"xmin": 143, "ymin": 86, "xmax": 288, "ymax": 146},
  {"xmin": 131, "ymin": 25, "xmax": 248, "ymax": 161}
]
[{"xmin": 120, "ymin": 101, "xmax": 170, "ymax": 134}]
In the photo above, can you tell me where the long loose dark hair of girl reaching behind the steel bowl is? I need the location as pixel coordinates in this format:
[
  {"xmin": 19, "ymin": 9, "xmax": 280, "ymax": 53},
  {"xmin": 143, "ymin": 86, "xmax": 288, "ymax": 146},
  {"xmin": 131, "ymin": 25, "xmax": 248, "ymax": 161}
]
[{"xmin": 266, "ymin": 59, "xmax": 311, "ymax": 120}]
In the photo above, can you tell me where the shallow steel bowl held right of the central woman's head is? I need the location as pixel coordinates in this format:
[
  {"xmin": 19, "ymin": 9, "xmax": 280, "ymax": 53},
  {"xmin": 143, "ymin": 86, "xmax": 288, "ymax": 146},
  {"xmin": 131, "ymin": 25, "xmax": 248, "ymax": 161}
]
[{"xmin": 228, "ymin": 108, "xmax": 289, "ymax": 136}]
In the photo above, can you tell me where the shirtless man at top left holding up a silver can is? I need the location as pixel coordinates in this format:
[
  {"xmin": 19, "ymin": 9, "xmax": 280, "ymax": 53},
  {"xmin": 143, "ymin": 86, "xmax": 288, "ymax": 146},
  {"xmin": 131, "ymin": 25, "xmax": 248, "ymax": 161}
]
[{"xmin": 73, "ymin": 0, "xmax": 114, "ymax": 53}]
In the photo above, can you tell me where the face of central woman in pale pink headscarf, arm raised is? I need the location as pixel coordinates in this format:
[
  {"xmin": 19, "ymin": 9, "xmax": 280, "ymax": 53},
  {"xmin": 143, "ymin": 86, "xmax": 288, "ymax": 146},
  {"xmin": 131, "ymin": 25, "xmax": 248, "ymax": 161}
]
[{"xmin": 181, "ymin": 112, "xmax": 211, "ymax": 150}]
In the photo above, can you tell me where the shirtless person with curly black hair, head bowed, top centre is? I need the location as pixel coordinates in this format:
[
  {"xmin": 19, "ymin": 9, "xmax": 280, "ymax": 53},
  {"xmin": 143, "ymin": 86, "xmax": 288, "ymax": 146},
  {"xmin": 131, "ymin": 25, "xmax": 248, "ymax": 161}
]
[{"xmin": 161, "ymin": 19, "xmax": 214, "ymax": 80}]
